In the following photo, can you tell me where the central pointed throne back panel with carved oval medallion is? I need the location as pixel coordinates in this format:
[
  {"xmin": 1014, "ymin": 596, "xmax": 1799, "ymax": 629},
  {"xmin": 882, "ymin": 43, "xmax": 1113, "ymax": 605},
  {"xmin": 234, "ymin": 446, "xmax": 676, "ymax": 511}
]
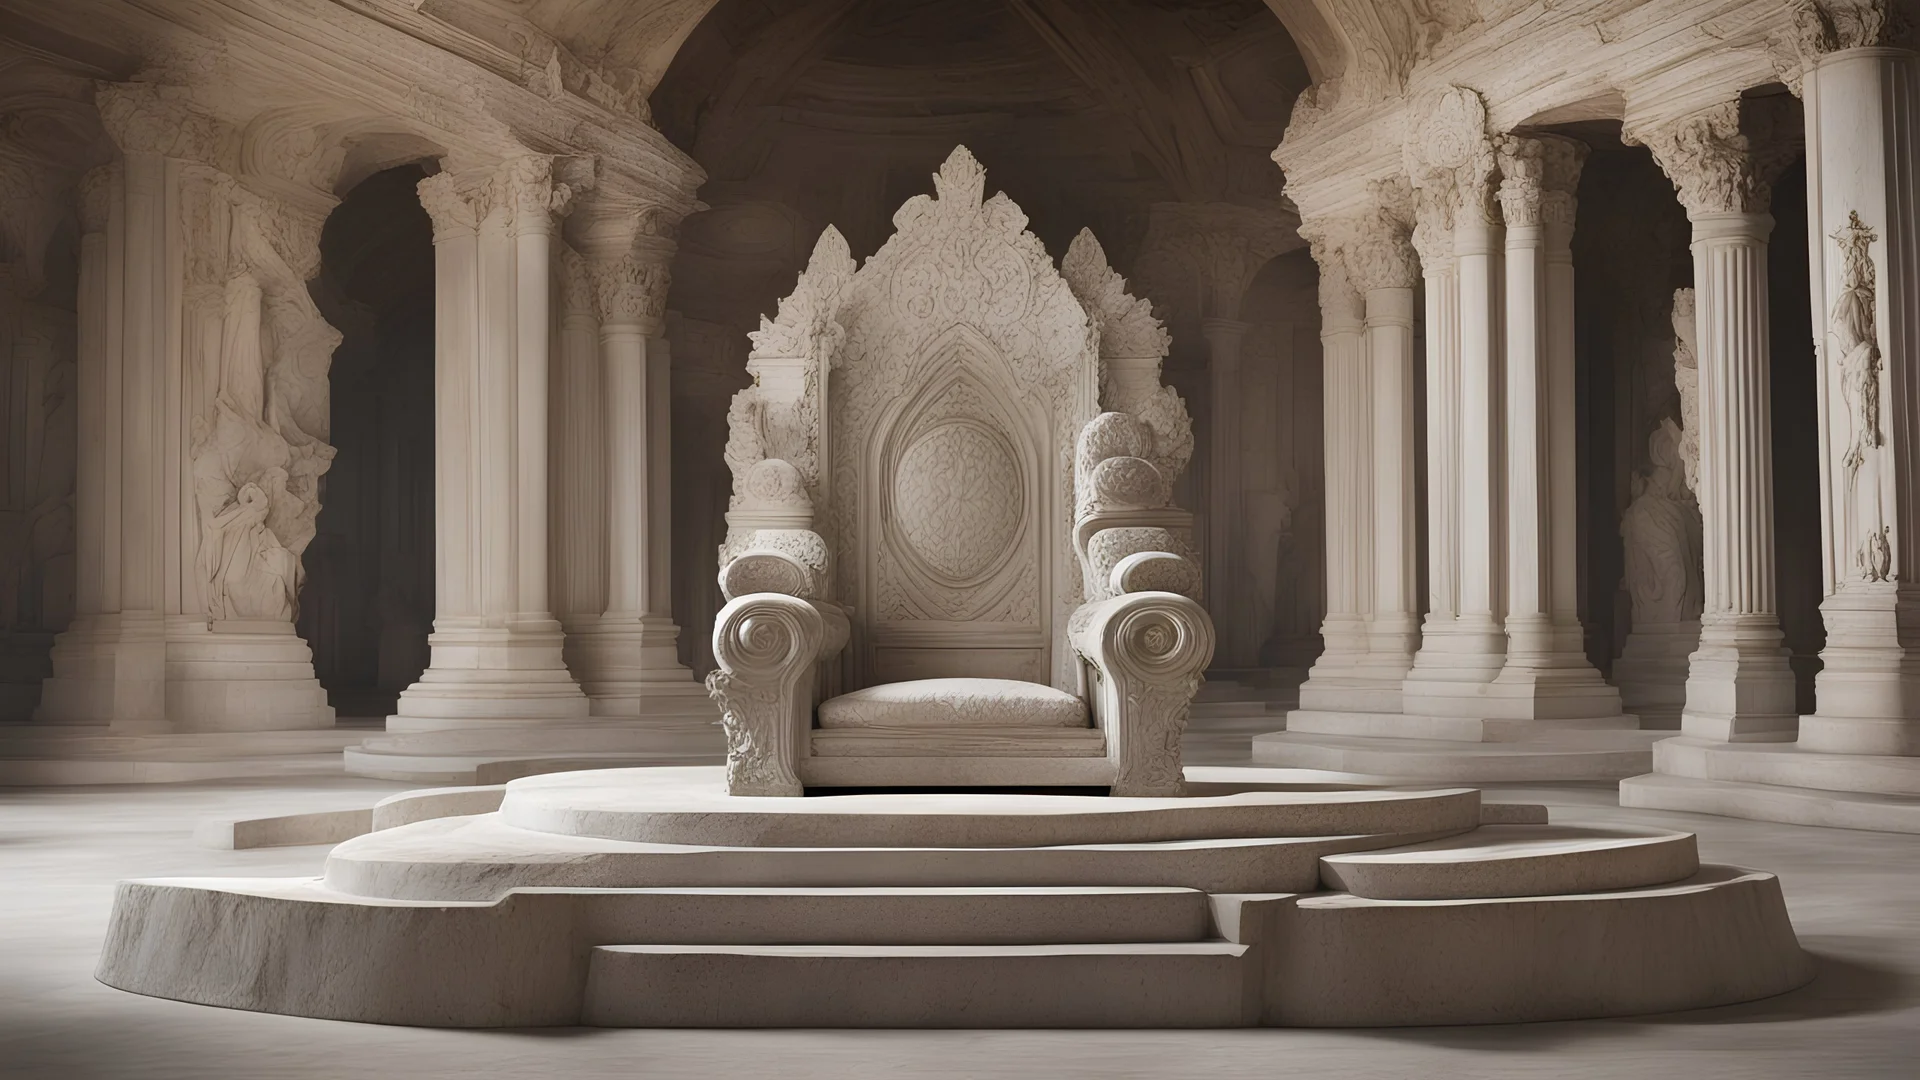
[{"xmin": 816, "ymin": 146, "xmax": 1100, "ymax": 688}]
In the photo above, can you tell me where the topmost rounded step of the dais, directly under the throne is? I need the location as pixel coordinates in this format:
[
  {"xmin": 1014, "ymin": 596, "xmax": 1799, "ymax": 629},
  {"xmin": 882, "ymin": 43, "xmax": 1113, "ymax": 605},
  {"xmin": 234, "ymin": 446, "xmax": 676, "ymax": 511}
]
[{"xmin": 499, "ymin": 767, "xmax": 1480, "ymax": 847}]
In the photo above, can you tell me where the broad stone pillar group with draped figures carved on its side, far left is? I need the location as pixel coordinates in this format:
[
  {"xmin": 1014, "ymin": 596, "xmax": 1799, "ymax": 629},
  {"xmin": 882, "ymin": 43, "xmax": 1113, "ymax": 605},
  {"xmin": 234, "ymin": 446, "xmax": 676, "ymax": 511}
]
[{"xmin": 36, "ymin": 85, "xmax": 340, "ymax": 734}]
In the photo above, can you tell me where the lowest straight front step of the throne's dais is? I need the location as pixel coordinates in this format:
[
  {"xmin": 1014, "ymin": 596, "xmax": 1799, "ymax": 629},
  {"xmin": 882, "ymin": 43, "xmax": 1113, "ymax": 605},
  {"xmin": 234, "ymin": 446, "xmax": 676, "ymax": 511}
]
[{"xmin": 582, "ymin": 942, "xmax": 1260, "ymax": 1028}]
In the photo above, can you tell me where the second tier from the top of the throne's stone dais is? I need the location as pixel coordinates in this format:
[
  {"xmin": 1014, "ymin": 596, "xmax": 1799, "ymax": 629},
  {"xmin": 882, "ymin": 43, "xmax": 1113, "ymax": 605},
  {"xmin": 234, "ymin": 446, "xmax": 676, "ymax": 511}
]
[{"xmin": 326, "ymin": 815, "xmax": 1446, "ymax": 901}]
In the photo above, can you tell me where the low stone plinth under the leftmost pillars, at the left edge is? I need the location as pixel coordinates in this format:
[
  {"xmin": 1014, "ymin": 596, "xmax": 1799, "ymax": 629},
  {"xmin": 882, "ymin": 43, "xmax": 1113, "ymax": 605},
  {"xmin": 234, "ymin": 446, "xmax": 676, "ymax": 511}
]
[{"xmin": 0, "ymin": 721, "xmax": 380, "ymax": 788}]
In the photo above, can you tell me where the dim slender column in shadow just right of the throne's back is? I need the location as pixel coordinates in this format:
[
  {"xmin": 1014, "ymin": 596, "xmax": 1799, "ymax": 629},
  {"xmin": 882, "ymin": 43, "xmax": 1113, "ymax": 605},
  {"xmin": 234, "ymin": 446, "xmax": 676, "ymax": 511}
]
[{"xmin": 1200, "ymin": 315, "xmax": 1258, "ymax": 667}]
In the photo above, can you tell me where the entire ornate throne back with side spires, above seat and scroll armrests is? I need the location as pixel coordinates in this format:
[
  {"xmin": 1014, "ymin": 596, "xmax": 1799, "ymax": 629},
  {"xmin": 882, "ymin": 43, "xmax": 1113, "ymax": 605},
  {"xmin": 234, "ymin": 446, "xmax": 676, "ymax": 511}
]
[{"xmin": 720, "ymin": 146, "xmax": 1198, "ymax": 690}]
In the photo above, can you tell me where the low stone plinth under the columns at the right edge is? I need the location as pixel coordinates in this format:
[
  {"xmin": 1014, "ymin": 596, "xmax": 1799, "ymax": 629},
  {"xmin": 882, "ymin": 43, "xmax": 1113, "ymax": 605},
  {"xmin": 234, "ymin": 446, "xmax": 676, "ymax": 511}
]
[{"xmin": 1620, "ymin": 736, "xmax": 1920, "ymax": 832}]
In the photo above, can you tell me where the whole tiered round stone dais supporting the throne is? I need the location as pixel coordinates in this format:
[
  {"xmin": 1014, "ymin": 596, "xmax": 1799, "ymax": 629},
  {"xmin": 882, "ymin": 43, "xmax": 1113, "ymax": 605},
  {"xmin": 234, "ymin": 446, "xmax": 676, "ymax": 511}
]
[{"xmin": 98, "ymin": 769, "xmax": 1811, "ymax": 1026}]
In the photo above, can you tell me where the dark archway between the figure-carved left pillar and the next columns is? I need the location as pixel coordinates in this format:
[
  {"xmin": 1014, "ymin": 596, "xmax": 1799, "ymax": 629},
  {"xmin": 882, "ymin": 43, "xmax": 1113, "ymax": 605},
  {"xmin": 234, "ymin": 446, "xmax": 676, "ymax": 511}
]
[{"xmin": 300, "ymin": 165, "xmax": 434, "ymax": 717}]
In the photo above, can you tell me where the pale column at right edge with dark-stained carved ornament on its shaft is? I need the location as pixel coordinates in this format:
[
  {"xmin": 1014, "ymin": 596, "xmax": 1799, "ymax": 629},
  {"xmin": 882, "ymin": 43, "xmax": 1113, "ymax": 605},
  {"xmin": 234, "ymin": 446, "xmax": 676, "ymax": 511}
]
[{"xmin": 1797, "ymin": 31, "xmax": 1920, "ymax": 755}]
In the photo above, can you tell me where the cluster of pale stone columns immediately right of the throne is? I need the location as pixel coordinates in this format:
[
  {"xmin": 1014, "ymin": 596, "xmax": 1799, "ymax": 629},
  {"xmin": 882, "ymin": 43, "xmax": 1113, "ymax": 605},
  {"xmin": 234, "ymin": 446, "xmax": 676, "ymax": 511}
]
[{"xmin": 1288, "ymin": 88, "xmax": 1630, "ymax": 740}]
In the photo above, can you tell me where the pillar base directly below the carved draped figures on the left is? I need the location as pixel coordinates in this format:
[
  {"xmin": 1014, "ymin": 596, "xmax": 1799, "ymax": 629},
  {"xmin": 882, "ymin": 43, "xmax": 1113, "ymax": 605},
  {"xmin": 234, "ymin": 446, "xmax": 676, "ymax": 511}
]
[{"xmin": 167, "ymin": 619, "xmax": 334, "ymax": 732}]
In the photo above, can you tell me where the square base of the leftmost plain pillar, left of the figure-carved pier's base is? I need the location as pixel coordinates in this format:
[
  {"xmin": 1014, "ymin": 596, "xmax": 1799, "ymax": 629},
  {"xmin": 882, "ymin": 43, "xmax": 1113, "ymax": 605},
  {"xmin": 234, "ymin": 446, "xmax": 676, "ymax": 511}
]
[{"xmin": 33, "ymin": 615, "xmax": 171, "ymax": 734}]
